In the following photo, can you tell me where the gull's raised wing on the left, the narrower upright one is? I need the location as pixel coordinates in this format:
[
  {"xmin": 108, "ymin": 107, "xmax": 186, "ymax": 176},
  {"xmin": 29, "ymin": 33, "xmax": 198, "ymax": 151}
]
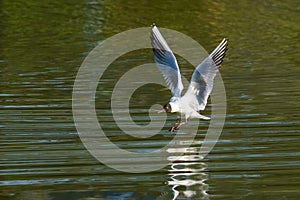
[{"xmin": 150, "ymin": 25, "xmax": 183, "ymax": 97}]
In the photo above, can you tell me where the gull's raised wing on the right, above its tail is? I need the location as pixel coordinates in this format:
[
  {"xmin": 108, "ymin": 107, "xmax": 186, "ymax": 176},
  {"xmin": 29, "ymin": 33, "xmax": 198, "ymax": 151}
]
[{"xmin": 183, "ymin": 38, "xmax": 227, "ymax": 111}]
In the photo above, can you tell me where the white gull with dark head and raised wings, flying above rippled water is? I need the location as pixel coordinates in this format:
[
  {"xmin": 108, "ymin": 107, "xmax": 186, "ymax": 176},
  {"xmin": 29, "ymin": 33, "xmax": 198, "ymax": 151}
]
[{"xmin": 150, "ymin": 25, "xmax": 227, "ymax": 131}]
